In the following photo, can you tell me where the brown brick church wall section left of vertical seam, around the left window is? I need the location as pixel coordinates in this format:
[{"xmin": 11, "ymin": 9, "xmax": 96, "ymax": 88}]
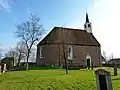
[{"xmin": 36, "ymin": 44, "xmax": 59, "ymax": 65}]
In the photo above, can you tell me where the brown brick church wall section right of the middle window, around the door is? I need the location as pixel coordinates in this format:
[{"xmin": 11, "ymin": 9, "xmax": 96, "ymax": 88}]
[{"xmin": 73, "ymin": 46, "xmax": 101, "ymax": 66}]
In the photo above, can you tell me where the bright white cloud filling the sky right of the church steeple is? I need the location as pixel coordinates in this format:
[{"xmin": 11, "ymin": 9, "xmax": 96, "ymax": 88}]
[{"xmin": 89, "ymin": 0, "xmax": 120, "ymax": 57}]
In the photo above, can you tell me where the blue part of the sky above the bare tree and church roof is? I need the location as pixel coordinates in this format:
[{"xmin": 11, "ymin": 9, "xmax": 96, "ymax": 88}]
[{"xmin": 0, "ymin": 0, "xmax": 91, "ymax": 53}]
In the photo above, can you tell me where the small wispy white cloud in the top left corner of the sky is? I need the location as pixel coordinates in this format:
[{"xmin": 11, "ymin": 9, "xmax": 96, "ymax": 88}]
[{"xmin": 0, "ymin": 0, "xmax": 11, "ymax": 12}]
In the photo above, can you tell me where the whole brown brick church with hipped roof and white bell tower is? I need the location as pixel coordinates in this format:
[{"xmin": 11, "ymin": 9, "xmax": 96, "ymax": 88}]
[{"xmin": 36, "ymin": 13, "xmax": 101, "ymax": 66}]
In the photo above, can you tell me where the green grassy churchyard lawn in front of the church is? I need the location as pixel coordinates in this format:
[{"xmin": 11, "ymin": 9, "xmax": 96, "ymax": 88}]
[{"xmin": 0, "ymin": 67, "xmax": 120, "ymax": 90}]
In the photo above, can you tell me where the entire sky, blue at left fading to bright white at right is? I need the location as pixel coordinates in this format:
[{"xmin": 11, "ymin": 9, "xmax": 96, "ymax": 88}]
[{"xmin": 0, "ymin": 0, "xmax": 120, "ymax": 57}]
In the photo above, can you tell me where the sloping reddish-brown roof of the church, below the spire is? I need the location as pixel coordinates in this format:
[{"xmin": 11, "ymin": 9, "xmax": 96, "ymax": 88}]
[{"xmin": 38, "ymin": 27, "xmax": 100, "ymax": 46}]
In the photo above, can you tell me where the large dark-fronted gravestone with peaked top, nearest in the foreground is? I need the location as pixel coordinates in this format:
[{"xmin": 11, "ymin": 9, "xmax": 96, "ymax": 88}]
[{"xmin": 95, "ymin": 69, "xmax": 113, "ymax": 90}]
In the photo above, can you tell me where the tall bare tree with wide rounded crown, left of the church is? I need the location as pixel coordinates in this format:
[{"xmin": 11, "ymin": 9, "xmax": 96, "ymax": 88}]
[{"xmin": 15, "ymin": 14, "xmax": 43, "ymax": 70}]
